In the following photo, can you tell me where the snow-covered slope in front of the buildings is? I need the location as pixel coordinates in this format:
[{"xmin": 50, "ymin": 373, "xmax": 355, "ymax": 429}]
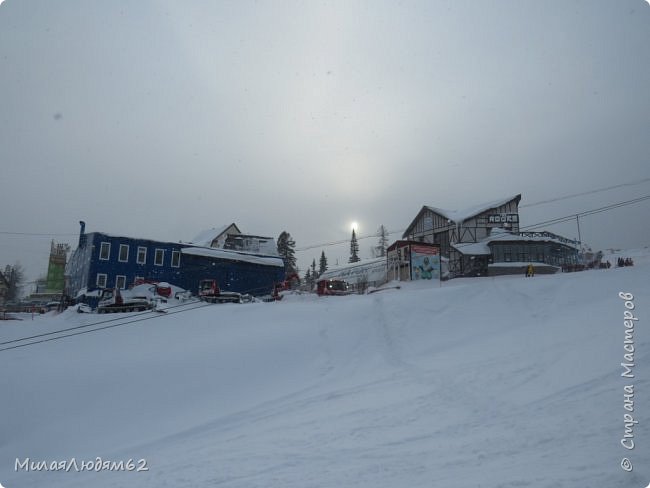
[{"xmin": 0, "ymin": 249, "xmax": 650, "ymax": 488}]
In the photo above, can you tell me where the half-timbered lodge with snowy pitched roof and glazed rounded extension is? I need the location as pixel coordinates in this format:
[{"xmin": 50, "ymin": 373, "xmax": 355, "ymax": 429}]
[{"xmin": 403, "ymin": 194, "xmax": 580, "ymax": 276}]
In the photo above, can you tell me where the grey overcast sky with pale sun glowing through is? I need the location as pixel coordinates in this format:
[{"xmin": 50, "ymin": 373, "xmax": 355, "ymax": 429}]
[{"xmin": 0, "ymin": 0, "xmax": 650, "ymax": 279}]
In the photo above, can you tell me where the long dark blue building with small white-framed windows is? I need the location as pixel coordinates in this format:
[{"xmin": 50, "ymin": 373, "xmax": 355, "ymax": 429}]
[{"xmin": 65, "ymin": 222, "xmax": 284, "ymax": 297}]
